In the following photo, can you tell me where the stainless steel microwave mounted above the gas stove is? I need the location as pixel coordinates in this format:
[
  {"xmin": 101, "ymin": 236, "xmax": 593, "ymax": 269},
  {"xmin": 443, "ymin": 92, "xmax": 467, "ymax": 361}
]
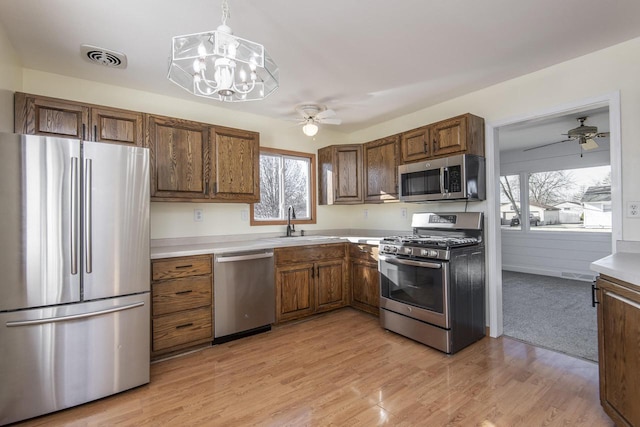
[{"xmin": 398, "ymin": 154, "xmax": 486, "ymax": 202}]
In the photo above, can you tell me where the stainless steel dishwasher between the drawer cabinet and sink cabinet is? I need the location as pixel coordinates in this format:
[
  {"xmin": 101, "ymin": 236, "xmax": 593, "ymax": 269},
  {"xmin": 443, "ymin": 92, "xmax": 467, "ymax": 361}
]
[{"xmin": 213, "ymin": 249, "xmax": 276, "ymax": 343}]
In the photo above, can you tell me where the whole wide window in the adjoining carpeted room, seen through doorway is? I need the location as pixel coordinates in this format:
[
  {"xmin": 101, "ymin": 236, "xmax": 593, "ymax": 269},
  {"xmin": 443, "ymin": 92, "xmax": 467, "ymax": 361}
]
[{"xmin": 500, "ymin": 166, "xmax": 611, "ymax": 232}]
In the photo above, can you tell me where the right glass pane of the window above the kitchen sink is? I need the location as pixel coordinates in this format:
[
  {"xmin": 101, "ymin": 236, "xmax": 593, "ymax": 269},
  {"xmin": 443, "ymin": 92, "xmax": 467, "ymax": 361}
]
[{"xmin": 284, "ymin": 157, "xmax": 310, "ymax": 219}]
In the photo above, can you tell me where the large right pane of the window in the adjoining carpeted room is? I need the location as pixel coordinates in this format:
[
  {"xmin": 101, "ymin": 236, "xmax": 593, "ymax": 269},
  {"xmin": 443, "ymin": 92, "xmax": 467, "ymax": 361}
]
[{"xmin": 529, "ymin": 166, "xmax": 611, "ymax": 231}]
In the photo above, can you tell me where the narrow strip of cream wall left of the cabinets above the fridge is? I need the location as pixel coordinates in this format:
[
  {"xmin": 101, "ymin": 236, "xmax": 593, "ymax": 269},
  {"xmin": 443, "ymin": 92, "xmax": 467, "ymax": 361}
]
[{"xmin": 0, "ymin": 21, "xmax": 22, "ymax": 132}]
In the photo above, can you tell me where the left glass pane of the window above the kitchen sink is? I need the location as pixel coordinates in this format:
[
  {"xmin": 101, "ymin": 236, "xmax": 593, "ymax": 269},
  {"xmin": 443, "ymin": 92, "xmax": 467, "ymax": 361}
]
[{"xmin": 253, "ymin": 154, "xmax": 282, "ymax": 220}]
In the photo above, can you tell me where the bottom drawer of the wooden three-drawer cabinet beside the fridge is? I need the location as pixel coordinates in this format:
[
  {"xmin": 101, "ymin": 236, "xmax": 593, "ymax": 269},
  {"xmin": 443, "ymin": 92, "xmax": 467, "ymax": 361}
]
[{"xmin": 153, "ymin": 307, "xmax": 213, "ymax": 351}]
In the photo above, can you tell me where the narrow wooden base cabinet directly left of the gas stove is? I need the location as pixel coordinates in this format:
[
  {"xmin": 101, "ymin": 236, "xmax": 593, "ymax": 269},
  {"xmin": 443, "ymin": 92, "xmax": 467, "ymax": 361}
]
[{"xmin": 349, "ymin": 243, "xmax": 380, "ymax": 316}]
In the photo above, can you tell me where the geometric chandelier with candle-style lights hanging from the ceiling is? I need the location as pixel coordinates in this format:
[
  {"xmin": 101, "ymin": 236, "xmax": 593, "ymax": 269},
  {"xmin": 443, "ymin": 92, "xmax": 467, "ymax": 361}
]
[{"xmin": 167, "ymin": 0, "xmax": 279, "ymax": 102}]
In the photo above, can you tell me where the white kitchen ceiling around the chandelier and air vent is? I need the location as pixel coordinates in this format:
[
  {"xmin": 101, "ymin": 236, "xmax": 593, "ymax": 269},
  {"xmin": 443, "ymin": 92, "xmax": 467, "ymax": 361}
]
[{"xmin": 0, "ymin": 0, "xmax": 640, "ymax": 132}]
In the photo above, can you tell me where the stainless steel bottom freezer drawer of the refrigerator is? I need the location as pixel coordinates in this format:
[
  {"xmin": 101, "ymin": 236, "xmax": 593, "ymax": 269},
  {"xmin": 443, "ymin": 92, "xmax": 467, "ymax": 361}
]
[{"xmin": 0, "ymin": 293, "xmax": 150, "ymax": 425}]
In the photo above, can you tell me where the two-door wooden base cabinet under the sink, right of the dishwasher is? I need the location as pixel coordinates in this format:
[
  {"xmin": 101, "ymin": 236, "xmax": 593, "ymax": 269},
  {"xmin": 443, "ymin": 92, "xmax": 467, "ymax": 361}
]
[{"xmin": 275, "ymin": 243, "xmax": 349, "ymax": 323}]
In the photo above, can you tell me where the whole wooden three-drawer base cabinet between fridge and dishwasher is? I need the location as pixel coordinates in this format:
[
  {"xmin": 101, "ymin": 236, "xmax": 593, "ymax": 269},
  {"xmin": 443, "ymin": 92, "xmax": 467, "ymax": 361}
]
[{"xmin": 151, "ymin": 255, "xmax": 213, "ymax": 359}]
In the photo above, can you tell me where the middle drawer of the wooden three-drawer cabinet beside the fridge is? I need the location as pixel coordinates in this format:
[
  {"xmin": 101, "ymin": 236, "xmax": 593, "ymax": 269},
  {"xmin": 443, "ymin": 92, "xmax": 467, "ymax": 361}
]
[{"xmin": 151, "ymin": 275, "xmax": 212, "ymax": 316}]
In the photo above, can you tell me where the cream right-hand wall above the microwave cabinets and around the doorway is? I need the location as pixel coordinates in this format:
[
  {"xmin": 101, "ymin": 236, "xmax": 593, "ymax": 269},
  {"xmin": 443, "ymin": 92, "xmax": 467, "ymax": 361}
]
[{"xmin": 349, "ymin": 38, "xmax": 640, "ymax": 241}]
